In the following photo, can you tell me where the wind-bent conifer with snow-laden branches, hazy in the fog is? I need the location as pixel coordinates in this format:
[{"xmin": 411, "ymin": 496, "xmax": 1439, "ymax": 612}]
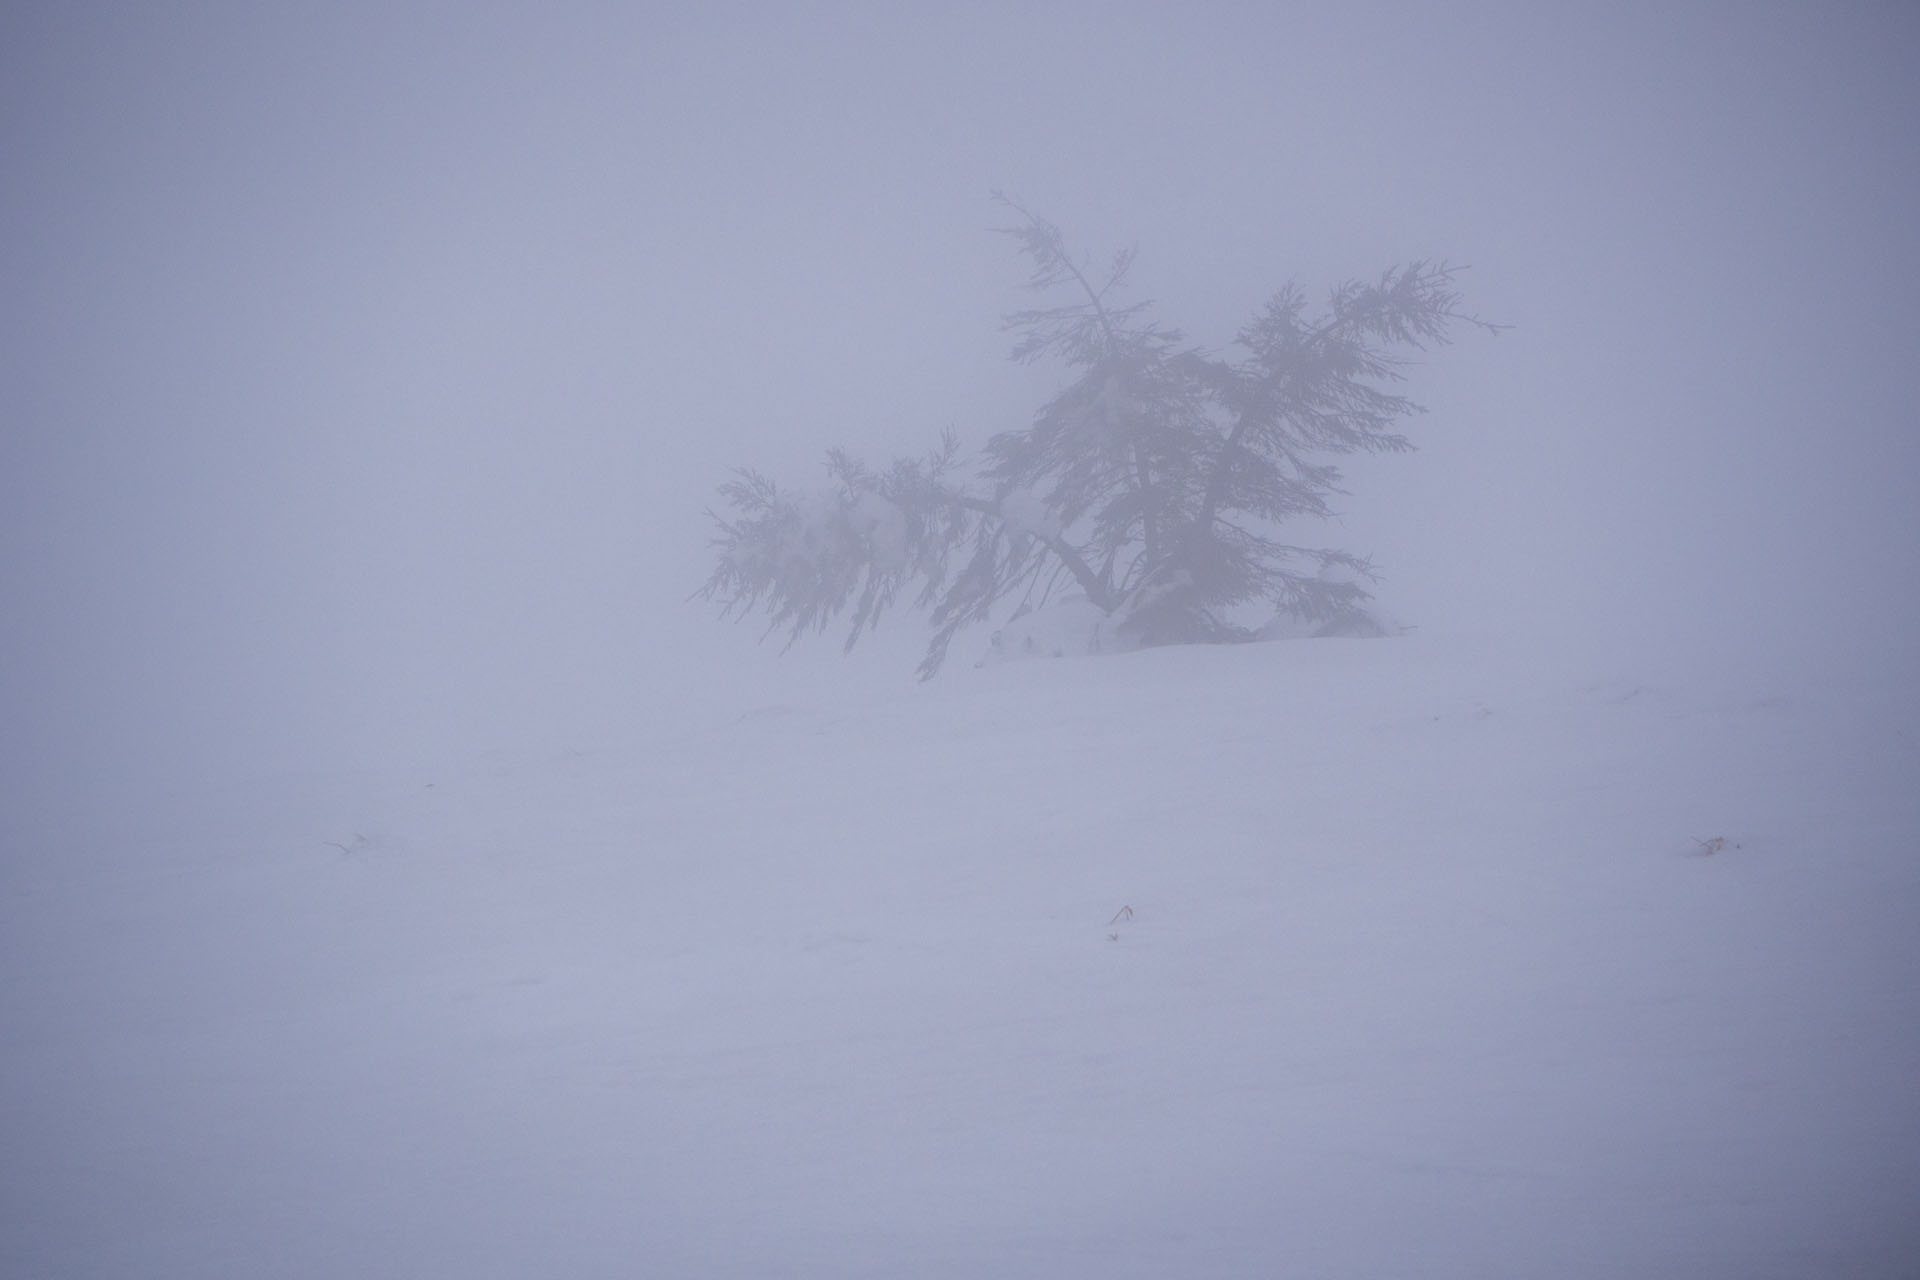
[{"xmin": 699, "ymin": 203, "xmax": 1494, "ymax": 677}]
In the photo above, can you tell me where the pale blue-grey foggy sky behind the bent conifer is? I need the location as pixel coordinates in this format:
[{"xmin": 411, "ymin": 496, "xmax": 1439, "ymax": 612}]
[{"xmin": 0, "ymin": 2, "xmax": 1920, "ymax": 787}]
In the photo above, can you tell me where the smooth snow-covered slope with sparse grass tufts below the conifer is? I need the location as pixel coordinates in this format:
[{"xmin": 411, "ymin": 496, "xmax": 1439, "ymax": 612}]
[{"xmin": 0, "ymin": 635, "xmax": 1920, "ymax": 1280}]
